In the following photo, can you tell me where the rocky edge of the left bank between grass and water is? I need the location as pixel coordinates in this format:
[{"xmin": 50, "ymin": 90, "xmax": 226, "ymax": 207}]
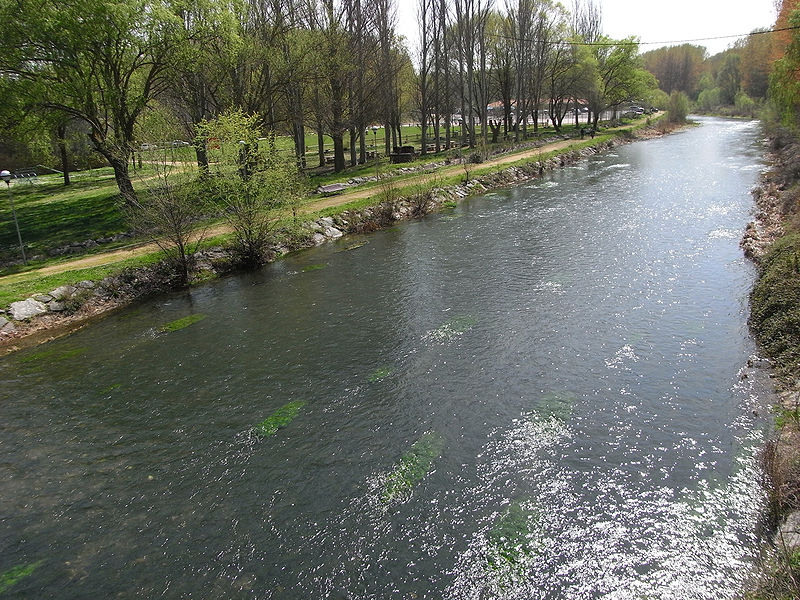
[{"xmin": 0, "ymin": 125, "xmax": 667, "ymax": 355}]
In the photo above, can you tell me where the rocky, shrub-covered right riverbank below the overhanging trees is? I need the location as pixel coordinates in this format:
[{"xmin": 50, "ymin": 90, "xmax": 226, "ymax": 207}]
[{"xmin": 741, "ymin": 126, "xmax": 800, "ymax": 599}]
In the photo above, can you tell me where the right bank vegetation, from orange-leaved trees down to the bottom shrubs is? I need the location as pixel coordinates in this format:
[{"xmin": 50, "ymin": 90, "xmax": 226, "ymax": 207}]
[{"xmin": 742, "ymin": 0, "xmax": 800, "ymax": 600}]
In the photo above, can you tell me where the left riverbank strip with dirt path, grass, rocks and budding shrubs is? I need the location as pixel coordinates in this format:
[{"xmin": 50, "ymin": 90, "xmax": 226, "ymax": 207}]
[{"xmin": 0, "ymin": 118, "xmax": 669, "ymax": 352}]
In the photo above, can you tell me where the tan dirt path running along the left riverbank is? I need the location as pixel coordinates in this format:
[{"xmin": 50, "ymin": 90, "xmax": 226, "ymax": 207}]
[{"xmin": 0, "ymin": 139, "xmax": 579, "ymax": 284}]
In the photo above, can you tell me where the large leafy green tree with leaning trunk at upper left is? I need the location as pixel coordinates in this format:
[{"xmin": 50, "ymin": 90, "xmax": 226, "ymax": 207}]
[{"xmin": 0, "ymin": 0, "xmax": 190, "ymax": 204}]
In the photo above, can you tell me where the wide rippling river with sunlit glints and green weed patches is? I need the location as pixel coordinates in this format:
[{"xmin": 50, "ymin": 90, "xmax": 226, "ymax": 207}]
[{"xmin": 0, "ymin": 119, "xmax": 770, "ymax": 600}]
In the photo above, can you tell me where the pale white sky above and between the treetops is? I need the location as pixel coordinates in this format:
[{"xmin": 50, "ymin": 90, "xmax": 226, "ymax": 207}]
[{"xmin": 397, "ymin": 0, "xmax": 775, "ymax": 54}]
